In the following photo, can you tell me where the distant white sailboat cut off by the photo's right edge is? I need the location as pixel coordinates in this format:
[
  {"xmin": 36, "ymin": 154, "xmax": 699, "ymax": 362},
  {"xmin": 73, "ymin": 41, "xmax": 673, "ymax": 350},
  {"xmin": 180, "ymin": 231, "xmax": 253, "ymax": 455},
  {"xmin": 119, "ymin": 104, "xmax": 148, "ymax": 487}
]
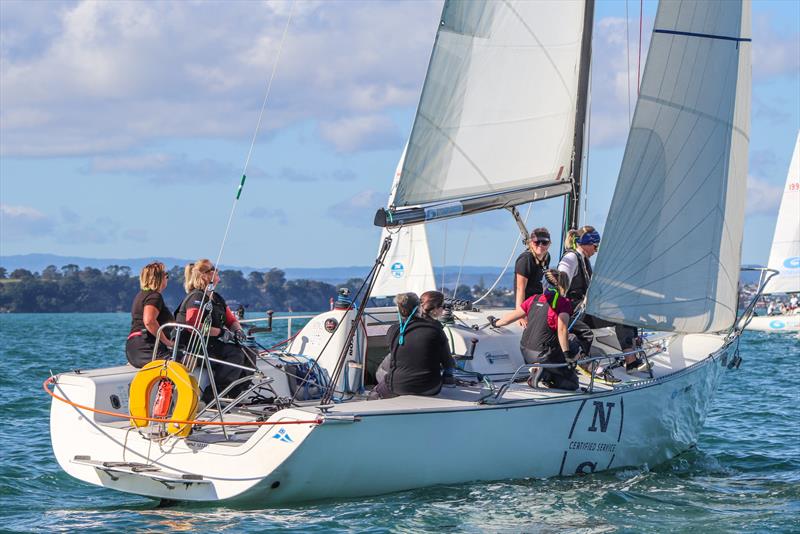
[{"xmin": 747, "ymin": 133, "xmax": 800, "ymax": 332}]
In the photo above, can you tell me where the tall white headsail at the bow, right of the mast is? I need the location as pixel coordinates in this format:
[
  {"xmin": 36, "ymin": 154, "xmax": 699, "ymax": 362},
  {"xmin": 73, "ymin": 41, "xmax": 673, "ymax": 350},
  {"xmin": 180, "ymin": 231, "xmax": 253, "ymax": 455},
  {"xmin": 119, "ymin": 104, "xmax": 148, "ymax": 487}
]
[{"xmin": 587, "ymin": 0, "xmax": 751, "ymax": 333}]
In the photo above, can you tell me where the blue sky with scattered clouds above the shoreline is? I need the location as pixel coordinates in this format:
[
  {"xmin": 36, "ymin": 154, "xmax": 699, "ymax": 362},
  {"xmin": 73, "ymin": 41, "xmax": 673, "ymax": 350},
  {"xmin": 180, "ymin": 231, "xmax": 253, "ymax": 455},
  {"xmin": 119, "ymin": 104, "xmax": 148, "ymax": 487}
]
[{"xmin": 0, "ymin": 0, "xmax": 800, "ymax": 267}]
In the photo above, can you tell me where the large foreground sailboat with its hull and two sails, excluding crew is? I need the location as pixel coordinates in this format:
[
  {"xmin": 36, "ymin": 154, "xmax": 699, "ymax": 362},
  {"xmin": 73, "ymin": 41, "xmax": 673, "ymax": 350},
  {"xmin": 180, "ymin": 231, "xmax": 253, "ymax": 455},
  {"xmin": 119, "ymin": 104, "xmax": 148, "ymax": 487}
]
[{"xmin": 46, "ymin": 0, "xmax": 764, "ymax": 505}]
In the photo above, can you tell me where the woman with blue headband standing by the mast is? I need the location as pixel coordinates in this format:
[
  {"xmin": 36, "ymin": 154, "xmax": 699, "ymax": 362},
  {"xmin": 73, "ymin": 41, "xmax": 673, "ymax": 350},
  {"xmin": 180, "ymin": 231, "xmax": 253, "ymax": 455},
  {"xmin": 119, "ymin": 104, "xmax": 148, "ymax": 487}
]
[{"xmin": 558, "ymin": 226, "xmax": 647, "ymax": 372}]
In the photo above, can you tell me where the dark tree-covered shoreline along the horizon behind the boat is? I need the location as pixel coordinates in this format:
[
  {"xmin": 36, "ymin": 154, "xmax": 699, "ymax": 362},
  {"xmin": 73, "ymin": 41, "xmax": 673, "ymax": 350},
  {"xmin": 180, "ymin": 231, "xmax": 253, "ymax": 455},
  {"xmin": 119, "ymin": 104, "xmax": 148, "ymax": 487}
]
[{"xmin": 0, "ymin": 264, "xmax": 513, "ymax": 313}]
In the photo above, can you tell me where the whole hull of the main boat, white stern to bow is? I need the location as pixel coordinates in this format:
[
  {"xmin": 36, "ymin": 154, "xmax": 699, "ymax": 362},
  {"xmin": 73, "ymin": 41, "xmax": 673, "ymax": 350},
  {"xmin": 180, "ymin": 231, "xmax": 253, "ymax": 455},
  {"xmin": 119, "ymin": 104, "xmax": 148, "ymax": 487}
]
[{"xmin": 51, "ymin": 338, "xmax": 732, "ymax": 505}]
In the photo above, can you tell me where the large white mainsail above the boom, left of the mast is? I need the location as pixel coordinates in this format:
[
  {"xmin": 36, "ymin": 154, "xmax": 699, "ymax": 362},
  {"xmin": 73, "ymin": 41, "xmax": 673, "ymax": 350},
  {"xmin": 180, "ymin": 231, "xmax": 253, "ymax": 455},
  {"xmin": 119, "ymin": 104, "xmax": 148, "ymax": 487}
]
[{"xmin": 393, "ymin": 0, "xmax": 584, "ymax": 207}]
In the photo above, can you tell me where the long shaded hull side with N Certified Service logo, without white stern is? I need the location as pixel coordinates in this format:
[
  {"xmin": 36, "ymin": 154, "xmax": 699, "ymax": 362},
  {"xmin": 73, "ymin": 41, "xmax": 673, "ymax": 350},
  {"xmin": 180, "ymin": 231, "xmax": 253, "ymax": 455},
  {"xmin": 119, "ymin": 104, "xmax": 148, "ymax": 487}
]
[{"xmin": 251, "ymin": 347, "xmax": 729, "ymax": 503}]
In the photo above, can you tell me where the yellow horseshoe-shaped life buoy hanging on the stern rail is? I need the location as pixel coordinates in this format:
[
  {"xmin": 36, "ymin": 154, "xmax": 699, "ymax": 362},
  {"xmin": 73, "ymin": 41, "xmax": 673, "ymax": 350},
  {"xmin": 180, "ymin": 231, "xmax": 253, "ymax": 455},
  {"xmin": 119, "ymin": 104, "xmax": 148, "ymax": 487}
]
[{"xmin": 128, "ymin": 360, "xmax": 200, "ymax": 437}]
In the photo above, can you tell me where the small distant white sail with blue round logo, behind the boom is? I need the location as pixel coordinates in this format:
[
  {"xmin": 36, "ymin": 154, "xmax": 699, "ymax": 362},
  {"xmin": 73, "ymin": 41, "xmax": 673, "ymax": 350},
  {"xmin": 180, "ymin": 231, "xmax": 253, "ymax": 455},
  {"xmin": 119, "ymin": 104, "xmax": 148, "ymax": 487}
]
[{"xmin": 371, "ymin": 147, "xmax": 436, "ymax": 297}]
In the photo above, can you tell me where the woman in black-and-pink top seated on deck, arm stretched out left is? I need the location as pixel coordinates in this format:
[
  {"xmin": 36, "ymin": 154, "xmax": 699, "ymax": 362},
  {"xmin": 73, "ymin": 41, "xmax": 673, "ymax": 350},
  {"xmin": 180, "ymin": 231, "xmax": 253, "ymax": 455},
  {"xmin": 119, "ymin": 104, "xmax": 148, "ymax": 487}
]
[{"xmin": 489, "ymin": 269, "xmax": 578, "ymax": 391}]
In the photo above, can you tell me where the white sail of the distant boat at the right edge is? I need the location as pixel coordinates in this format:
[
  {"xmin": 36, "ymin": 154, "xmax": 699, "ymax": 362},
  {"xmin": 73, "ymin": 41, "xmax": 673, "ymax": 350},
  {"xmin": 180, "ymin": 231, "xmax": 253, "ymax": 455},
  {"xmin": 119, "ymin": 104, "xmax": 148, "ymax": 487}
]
[{"xmin": 764, "ymin": 133, "xmax": 800, "ymax": 293}]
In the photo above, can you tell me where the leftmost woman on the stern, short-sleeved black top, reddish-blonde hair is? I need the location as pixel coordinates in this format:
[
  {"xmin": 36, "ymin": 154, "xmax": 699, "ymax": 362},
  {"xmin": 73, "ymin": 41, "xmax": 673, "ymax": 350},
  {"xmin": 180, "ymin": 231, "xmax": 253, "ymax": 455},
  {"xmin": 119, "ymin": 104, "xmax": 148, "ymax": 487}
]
[{"xmin": 125, "ymin": 262, "xmax": 174, "ymax": 368}]
